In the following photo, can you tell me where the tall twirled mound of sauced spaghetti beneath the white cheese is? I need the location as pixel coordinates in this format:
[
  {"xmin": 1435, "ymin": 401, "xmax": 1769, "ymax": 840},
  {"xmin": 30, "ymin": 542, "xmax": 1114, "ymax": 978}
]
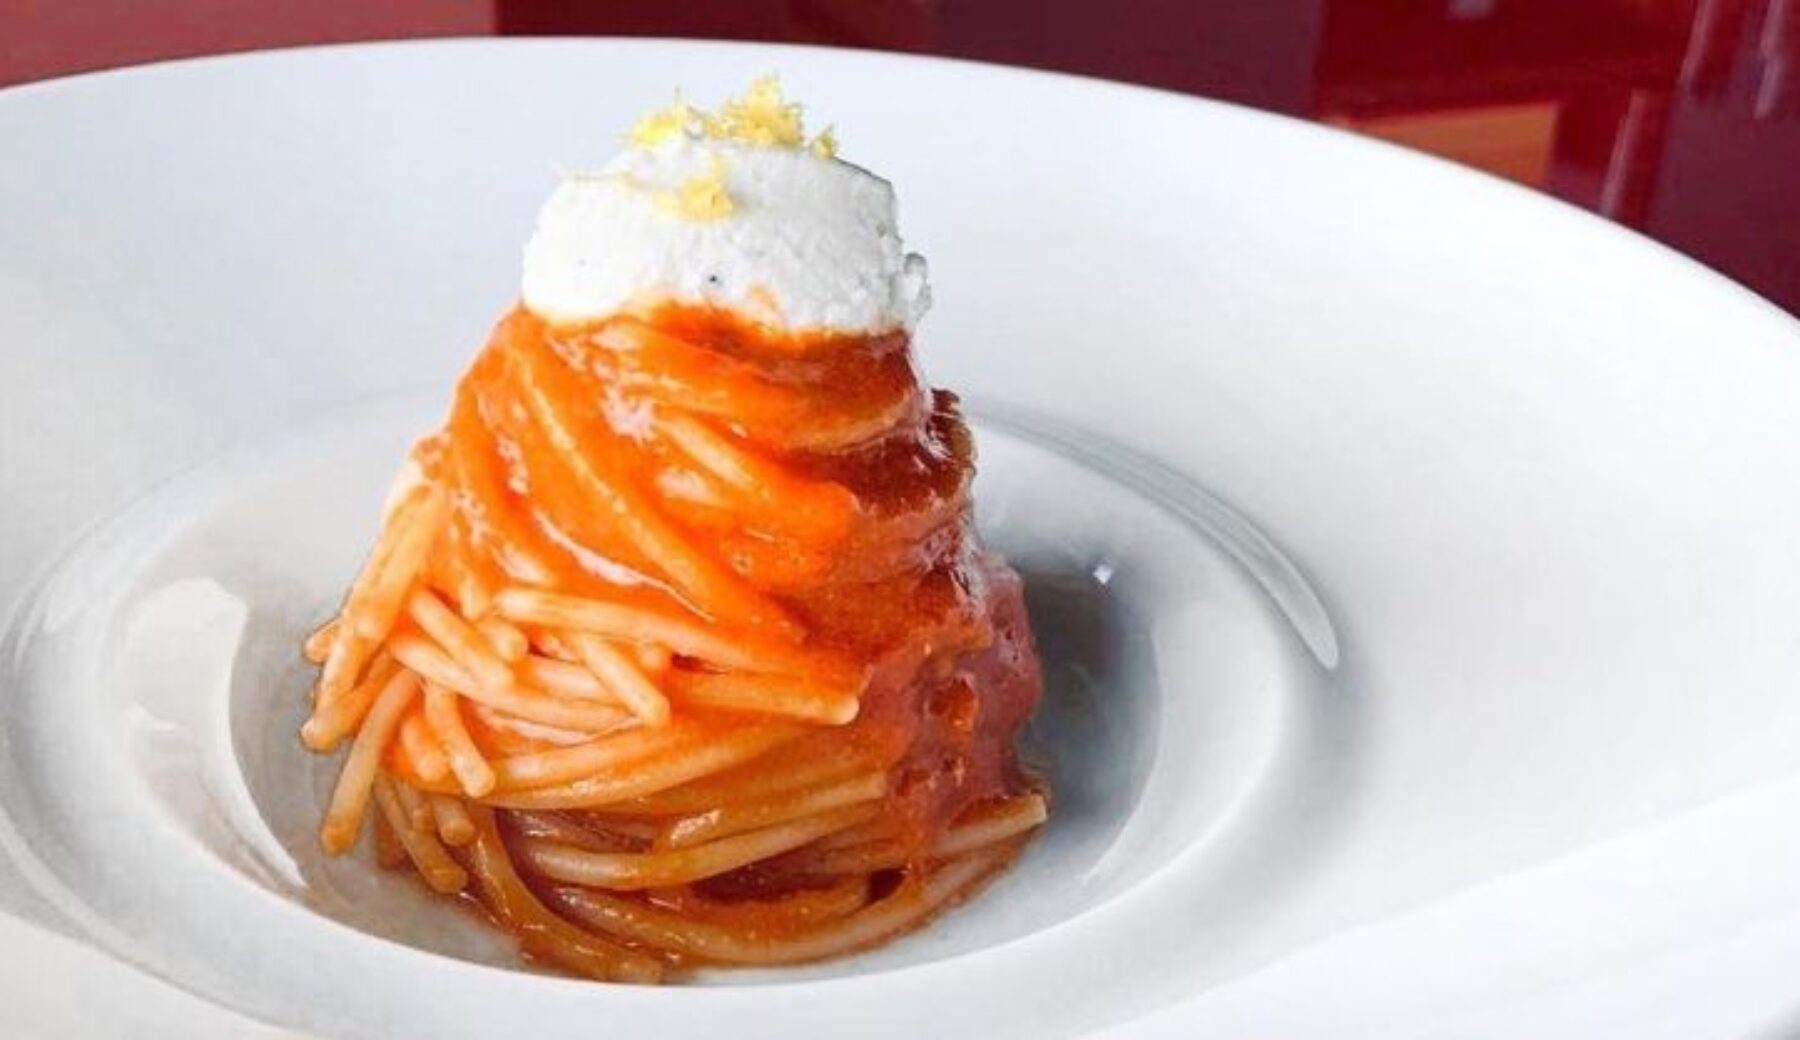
[{"xmin": 302, "ymin": 304, "xmax": 1046, "ymax": 982}]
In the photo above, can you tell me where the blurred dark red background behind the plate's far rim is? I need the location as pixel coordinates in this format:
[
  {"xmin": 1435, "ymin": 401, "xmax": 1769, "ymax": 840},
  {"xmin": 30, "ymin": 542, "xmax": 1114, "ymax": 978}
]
[{"xmin": 10, "ymin": 0, "xmax": 1800, "ymax": 313}]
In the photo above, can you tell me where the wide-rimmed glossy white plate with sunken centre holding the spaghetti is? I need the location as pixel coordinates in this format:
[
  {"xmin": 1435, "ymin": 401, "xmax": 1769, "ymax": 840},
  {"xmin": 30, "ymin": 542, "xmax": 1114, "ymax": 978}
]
[{"xmin": 0, "ymin": 41, "xmax": 1800, "ymax": 1040}]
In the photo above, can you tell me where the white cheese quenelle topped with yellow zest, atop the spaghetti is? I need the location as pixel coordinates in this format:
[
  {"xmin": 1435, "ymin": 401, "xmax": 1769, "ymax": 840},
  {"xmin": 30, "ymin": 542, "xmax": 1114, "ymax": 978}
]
[{"xmin": 520, "ymin": 77, "xmax": 931, "ymax": 333}]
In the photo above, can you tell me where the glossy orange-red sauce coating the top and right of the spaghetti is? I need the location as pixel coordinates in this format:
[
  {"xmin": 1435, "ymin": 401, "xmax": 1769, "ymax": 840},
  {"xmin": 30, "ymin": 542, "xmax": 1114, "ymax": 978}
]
[{"xmin": 410, "ymin": 309, "xmax": 1040, "ymax": 927}]
